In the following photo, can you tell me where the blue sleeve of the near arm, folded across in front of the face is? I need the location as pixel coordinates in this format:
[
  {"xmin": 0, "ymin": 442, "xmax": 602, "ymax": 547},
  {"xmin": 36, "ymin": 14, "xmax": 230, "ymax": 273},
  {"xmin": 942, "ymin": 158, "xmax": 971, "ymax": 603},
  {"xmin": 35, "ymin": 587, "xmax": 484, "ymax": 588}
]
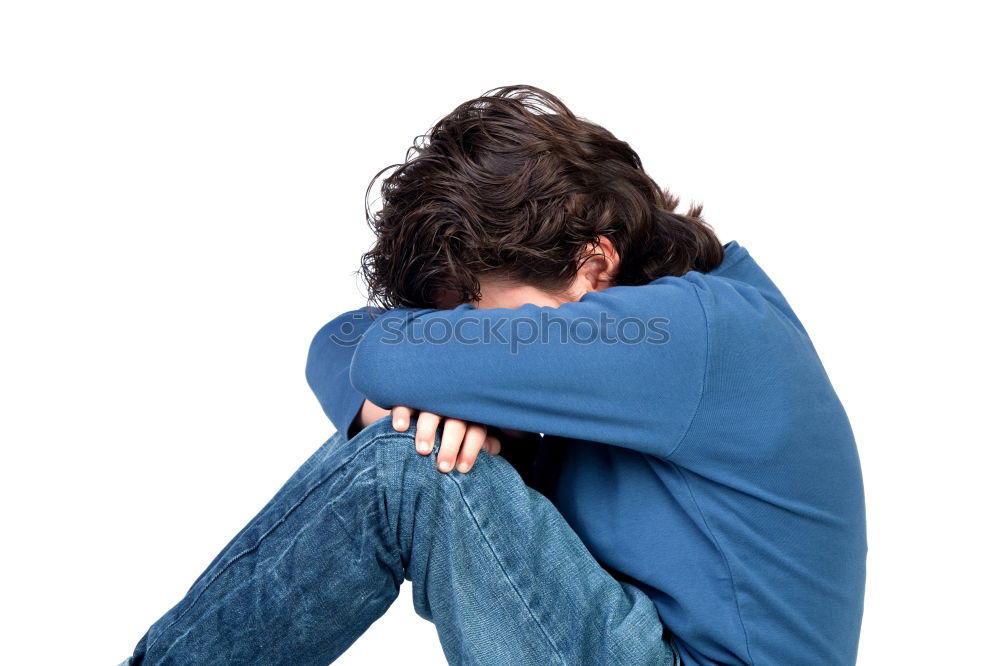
[{"xmin": 349, "ymin": 277, "xmax": 708, "ymax": 458}]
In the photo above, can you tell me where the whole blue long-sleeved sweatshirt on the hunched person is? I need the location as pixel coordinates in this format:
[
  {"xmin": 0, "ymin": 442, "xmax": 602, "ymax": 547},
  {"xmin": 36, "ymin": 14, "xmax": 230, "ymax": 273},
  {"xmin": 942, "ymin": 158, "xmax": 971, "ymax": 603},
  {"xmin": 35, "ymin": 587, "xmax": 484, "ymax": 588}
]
[{"xmin": 306, "ymin": 241, "xmax": 867, "ymax": 666}]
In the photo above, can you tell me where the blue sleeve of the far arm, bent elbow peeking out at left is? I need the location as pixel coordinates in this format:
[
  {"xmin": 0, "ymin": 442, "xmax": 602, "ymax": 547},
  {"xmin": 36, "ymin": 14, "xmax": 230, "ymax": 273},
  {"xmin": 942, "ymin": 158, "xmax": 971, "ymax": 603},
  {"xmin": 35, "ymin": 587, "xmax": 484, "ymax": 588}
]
[{"xmin": 306, "ymin": 307, "xmax": 385, "ymax": 435}]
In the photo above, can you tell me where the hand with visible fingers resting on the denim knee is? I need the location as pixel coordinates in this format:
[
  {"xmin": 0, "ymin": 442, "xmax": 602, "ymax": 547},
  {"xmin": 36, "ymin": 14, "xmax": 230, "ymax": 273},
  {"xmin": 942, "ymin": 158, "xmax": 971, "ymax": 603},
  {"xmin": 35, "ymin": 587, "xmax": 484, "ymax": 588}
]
[{"xmin": 392, "ymin": 405, "xmax": 500, "ymax": 474}]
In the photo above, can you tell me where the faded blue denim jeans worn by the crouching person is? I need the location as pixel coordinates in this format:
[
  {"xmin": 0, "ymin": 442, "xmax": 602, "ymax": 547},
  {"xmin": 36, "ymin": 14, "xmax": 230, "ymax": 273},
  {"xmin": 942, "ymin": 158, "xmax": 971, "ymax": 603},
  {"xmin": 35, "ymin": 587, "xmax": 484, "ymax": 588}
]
[{"xmin": 117, "ymin": 417, "xmax": 679, "ymax": 666}]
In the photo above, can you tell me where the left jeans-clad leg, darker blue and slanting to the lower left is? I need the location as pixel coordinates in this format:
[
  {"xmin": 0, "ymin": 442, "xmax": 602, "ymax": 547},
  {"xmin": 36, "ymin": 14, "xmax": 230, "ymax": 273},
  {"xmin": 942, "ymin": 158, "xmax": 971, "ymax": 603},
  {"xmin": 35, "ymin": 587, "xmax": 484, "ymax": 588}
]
[{"xmin": 122, "ymin": 424, "xmax": 412, "ymax": 666}]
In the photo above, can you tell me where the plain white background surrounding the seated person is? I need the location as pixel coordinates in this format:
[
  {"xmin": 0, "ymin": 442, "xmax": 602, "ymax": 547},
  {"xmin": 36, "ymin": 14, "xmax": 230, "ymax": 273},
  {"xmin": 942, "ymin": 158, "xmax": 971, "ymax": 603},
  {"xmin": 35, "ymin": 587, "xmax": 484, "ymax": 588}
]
[{"xmin": 0, "ymin": 0, "xmax": 1000, "ymax": 665}]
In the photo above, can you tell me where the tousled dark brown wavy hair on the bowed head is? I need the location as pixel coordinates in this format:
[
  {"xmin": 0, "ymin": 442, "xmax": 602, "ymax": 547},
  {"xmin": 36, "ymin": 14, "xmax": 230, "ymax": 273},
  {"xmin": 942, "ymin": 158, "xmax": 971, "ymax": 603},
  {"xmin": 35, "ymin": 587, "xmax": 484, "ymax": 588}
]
[{"xmin": 357, "ymin": 85, "xmax": 723, "ymax": 309}]
